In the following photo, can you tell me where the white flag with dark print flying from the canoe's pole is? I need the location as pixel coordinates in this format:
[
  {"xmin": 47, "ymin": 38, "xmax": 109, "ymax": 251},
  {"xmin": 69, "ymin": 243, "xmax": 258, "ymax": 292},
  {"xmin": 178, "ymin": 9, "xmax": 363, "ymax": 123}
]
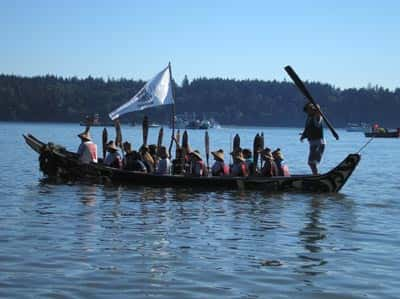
[{"xmin": 109, "ymin": 66, "xmax": 174, "ymax": 120}]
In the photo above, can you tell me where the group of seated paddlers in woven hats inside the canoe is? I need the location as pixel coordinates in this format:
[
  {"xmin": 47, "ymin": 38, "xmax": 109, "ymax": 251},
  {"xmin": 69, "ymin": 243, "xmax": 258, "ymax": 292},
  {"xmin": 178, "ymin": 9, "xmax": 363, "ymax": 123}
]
[{"xmin": 78, "ymin": 132, "xmax": 290, "ymax": 177}]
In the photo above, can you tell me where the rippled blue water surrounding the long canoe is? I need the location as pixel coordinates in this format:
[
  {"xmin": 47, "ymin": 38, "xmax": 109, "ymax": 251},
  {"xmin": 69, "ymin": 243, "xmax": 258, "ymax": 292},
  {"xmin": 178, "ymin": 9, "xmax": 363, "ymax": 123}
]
[{"xmin": 0, "ymin": 123, "xmax": 400, "ymax": 298}]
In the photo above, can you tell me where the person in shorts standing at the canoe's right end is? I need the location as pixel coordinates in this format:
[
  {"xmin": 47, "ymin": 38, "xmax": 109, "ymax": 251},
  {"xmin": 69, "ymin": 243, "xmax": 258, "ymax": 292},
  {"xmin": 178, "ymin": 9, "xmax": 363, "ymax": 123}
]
[{"xmin": 300, "ymin": 103, "xmax": 325, "ymax": 175}]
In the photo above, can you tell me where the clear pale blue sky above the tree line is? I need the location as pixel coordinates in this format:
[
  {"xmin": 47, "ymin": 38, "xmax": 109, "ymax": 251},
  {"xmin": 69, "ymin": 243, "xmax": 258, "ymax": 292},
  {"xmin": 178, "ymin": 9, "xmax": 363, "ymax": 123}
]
[{"xmin": 0, "ymin": 0, "xmax": 400, "ymax": 89}]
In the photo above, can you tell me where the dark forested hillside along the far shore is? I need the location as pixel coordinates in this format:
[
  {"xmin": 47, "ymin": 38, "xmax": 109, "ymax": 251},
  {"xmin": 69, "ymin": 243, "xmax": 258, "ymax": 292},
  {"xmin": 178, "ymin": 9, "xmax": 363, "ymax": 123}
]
[{"xmin": 0, "ymin": 75, "xmax": 400, "ymax": 127}]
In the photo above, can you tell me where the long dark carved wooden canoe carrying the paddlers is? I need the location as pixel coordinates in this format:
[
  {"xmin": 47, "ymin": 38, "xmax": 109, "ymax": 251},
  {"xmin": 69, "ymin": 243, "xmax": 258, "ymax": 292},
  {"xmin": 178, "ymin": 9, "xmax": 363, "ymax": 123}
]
[{"xmin": 23, "ymin": 134, "xmax": 361, "ymax": 193}]
